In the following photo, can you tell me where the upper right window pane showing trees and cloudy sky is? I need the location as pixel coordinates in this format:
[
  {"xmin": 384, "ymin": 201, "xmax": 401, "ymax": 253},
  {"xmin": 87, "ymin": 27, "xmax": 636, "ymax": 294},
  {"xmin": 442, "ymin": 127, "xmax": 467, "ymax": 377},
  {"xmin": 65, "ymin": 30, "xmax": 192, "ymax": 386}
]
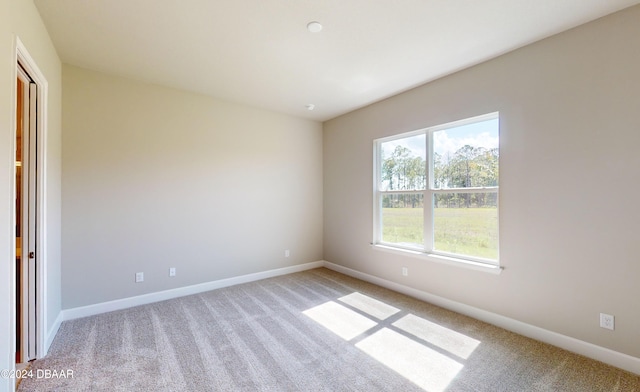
[{"xmin": 433, "ymin": 118, "xmax": 499, "ymax": 189}]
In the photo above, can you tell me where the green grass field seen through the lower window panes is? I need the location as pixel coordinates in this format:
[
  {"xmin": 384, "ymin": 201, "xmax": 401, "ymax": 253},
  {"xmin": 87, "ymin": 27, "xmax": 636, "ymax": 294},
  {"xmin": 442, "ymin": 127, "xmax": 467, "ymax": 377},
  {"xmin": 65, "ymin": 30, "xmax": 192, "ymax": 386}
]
[{"xmin": 382, "ymin": 207, "xmax": 498, "ymax": 259}]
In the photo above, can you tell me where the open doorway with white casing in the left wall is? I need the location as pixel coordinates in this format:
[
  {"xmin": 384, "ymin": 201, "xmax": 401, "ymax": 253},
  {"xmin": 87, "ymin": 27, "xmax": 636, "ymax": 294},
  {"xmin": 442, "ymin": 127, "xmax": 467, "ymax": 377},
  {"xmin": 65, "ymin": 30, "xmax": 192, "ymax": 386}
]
[{"xmin": 11, "ymin": 37, "xmax": 50, "ymax": 381}]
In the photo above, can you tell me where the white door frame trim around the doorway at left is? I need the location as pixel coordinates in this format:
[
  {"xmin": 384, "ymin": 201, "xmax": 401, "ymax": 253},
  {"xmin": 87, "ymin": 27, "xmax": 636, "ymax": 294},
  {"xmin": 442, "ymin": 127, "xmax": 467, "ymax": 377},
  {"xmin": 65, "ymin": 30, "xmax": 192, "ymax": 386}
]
[{"xmin": 10, "ymin": 35, "xmax": 48, "ymax": 358}]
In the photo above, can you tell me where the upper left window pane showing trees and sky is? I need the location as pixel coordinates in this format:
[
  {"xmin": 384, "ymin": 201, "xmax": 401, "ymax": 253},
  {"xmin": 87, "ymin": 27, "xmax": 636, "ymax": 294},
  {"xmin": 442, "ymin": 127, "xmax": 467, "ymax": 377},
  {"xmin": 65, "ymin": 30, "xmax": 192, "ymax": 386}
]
[{"xmin": 380, "ymin": 134, "xmax": 427, "ymax": 191}]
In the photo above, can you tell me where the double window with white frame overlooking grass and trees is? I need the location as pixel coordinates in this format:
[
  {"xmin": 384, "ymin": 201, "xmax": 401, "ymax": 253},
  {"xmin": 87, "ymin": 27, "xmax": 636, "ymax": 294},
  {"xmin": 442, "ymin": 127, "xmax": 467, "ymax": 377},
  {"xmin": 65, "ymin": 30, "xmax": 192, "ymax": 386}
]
[{"xmin": 374, "ymin": 113, "xmax": 499, "ymax": 265}]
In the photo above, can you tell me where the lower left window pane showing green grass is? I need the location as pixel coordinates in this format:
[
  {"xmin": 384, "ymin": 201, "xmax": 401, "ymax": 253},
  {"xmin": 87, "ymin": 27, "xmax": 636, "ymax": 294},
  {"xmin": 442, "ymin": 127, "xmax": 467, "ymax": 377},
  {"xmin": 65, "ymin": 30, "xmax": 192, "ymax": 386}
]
[{"xmin": 382, "ymin": 194, "xmax": 424, "ymax": 249}]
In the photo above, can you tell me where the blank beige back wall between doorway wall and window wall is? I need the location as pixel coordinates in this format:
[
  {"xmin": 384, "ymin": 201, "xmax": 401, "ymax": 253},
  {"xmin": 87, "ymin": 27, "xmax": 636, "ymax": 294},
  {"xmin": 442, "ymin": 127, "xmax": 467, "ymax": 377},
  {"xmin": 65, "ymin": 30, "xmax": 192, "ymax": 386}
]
[{"xmin": 62, "ymin": 65, "xmax": 322, "ymax": 309}]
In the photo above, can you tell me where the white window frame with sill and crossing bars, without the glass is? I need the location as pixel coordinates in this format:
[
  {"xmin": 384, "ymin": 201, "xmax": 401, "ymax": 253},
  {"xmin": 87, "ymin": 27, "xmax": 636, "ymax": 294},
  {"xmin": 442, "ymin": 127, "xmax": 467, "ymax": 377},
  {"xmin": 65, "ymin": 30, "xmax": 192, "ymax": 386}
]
[{"xmin": 372, "ymin": 112, "xmax": 501, "ymax": 273}]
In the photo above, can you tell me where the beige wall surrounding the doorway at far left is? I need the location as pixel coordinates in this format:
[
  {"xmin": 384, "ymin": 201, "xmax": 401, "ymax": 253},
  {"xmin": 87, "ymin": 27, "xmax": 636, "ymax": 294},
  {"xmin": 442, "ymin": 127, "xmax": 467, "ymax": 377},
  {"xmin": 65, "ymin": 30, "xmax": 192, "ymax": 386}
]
[{"xmin": 0, "ymin": 0, "xmax": 61, "ymax": 390}]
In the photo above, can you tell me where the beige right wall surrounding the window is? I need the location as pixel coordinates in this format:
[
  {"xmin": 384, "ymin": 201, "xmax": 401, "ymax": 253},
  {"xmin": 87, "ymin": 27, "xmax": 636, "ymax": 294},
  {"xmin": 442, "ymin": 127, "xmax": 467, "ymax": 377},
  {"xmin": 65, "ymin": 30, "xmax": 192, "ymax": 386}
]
[{"xmin": 324, "ymin": 6, "xmax": 640, "ymax": 357}]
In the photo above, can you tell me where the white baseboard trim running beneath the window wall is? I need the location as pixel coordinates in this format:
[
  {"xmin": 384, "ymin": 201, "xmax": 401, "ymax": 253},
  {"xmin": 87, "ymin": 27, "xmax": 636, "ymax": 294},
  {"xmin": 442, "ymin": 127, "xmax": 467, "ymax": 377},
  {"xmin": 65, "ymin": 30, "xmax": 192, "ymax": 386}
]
[{"xmin": 324, "ymin": 261, "xmax": 640, "ymax": 375}]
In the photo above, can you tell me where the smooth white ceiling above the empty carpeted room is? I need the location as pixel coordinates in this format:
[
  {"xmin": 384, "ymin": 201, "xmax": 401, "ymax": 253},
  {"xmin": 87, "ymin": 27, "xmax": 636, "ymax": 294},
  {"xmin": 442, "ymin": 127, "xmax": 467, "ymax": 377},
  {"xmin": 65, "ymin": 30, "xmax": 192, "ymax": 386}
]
[{"xmin": 34, "ymin": 0, "xmax": 640, "ymax": 121}]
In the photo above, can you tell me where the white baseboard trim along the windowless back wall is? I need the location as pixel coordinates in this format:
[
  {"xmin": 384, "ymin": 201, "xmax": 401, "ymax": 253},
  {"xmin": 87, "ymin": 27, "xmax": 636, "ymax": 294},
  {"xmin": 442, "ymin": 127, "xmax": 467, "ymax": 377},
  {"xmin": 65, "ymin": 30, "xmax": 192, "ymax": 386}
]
[{"xmin": 62, "ymin": 261, "xmax": 324, "ymax": 322}]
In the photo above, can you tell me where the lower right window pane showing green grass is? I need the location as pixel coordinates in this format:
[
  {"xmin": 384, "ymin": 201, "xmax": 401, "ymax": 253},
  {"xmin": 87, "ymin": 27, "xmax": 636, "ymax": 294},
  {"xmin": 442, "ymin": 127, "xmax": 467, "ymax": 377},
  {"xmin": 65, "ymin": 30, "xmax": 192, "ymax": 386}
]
[{"xmin": 433, "ymin": 192, "xmax": 498, "ymax": 260}]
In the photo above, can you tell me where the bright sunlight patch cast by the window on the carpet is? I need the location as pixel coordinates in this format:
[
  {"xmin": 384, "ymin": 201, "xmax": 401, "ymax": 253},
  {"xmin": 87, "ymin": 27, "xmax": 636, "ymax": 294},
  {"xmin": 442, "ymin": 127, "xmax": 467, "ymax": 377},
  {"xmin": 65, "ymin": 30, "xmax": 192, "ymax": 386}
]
[{"xmin": 303, "ymin": 292, "xmax": 481, "ymax": 392}]
